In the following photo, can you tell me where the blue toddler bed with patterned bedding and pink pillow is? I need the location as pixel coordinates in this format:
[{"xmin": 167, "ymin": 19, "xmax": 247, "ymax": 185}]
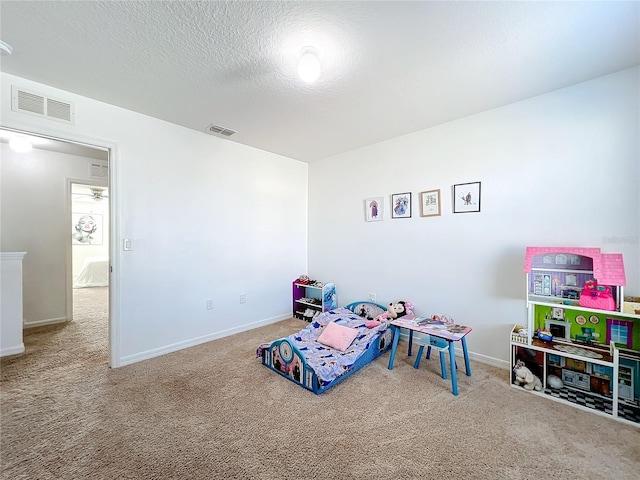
[{"xmin": 257, "ymin": 301, "xmax": 393, "ymax": 394}]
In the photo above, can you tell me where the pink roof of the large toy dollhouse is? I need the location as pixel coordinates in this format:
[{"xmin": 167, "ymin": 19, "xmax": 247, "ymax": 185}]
[{"xmin": 524, "ymin": 247, "xmax": 627, "ymax": 286}]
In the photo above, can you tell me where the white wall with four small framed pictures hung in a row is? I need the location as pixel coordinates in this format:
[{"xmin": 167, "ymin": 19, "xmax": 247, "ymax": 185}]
[{"xmin": 309, "ymin": 68, "xmax": 640, "ymax": 365}]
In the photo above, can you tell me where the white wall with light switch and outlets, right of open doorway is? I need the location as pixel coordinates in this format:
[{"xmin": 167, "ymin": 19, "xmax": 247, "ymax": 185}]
[{"xmin": 0, "ymin": 74, "xmax": 308, "ymax": 365}]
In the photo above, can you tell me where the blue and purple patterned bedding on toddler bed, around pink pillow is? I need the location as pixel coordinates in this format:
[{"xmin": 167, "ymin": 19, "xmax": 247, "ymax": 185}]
[{"xmin": 287, "ymin": 307, "xmax": 393, "ymax": 384}]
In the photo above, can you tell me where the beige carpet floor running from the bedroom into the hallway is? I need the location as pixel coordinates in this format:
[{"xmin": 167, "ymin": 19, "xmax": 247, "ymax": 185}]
[{"xmin": 0, "ymin": 288, "xmax": 640, "ymax": 480}]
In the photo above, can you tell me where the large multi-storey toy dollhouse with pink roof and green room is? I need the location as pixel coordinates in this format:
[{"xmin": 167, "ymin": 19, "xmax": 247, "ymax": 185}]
[{"xmin": 510, "ymin": 247, "xmax": 640, "ymax": 426}]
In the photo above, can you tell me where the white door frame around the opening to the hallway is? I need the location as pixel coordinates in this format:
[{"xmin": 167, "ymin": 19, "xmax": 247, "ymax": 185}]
[{"xmin": 0, "ymin": 121, "xmax": 121, "ymax": 368}]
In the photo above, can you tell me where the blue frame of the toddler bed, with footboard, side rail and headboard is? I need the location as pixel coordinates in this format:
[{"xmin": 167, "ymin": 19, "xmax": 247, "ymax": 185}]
[{"xmin": 262, "ymin": 301, "xmax": 393, "ymax": 394}]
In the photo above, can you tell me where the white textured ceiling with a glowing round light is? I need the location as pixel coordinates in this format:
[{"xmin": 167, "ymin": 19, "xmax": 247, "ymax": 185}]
[{"xmin": 0, "ymin": 0, "xmax": 640, "ymax": 162}]
